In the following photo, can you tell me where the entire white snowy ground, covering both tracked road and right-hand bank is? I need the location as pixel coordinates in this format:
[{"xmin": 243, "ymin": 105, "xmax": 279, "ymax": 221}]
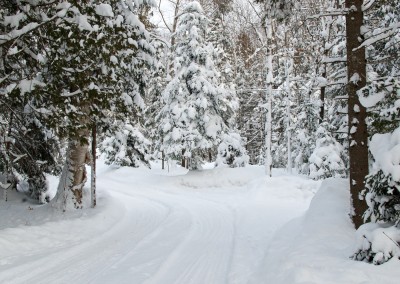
[{"xmin": 0, "ymin": 161, "xmax": 400, "ymax": 284}]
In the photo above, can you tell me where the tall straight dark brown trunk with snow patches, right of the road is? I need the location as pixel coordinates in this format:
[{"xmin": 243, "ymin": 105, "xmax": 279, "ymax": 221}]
[{"xmin": 346, "ymin": 0, "xmax": 368, "ymax": 228}]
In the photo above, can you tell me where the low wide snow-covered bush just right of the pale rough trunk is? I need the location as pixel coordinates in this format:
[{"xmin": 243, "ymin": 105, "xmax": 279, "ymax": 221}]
[{"xmin": 100, "ymin": 123, "xmax": 151, "ymax": 168}]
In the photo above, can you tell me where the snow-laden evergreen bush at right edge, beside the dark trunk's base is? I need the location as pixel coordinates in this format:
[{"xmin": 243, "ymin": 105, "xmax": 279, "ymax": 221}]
[{"xmin": 353, "ymin": 127, "xmax": 400, "ymax": 264}]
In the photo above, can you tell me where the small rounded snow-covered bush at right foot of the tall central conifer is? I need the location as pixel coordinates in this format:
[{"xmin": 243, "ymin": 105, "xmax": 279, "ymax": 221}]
[{"xmin": 215, "ymin": 133, "xmax": 249, "ymax": 168}]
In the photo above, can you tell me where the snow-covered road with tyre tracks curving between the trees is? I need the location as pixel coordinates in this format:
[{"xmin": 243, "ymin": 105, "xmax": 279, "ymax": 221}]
[{"xmin": 0, "ymin": 167, "xmax": 318, "ymax": 284}]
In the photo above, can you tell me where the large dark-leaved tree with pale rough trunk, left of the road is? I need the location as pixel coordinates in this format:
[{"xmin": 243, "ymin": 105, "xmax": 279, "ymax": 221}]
[{"xmin": 45, "ymin": 0, "xmax": 154, "ymax": 208}]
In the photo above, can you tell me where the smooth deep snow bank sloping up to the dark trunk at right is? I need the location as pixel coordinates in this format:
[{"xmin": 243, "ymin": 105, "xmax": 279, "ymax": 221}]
[{"xmin": 253, "ymin": 179, "xmax": 400, "ymax": 284}]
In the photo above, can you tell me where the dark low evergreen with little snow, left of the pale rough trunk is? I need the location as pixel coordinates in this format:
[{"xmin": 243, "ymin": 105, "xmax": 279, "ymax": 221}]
[{"xmin": 0, "ymin": 110, "xmax": 61, "ymax": 203}]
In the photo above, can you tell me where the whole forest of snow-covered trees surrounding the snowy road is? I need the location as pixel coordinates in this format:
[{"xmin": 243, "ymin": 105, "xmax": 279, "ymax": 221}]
[{"xmin": 0, "ymin": 0, "xmax": 400, "ymax": 264}]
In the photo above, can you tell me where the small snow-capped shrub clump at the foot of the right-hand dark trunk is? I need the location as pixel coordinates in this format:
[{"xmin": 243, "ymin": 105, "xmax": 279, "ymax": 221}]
[{"xmin": 352, "ymin": 223, "xmax": 400, "ymax": 265}]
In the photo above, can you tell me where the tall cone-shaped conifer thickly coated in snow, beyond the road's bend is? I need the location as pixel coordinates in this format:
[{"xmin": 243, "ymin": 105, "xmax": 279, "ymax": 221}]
[{"xmin": 159, "ymin": 1, "xmax": 233, "ymax": 169}]
